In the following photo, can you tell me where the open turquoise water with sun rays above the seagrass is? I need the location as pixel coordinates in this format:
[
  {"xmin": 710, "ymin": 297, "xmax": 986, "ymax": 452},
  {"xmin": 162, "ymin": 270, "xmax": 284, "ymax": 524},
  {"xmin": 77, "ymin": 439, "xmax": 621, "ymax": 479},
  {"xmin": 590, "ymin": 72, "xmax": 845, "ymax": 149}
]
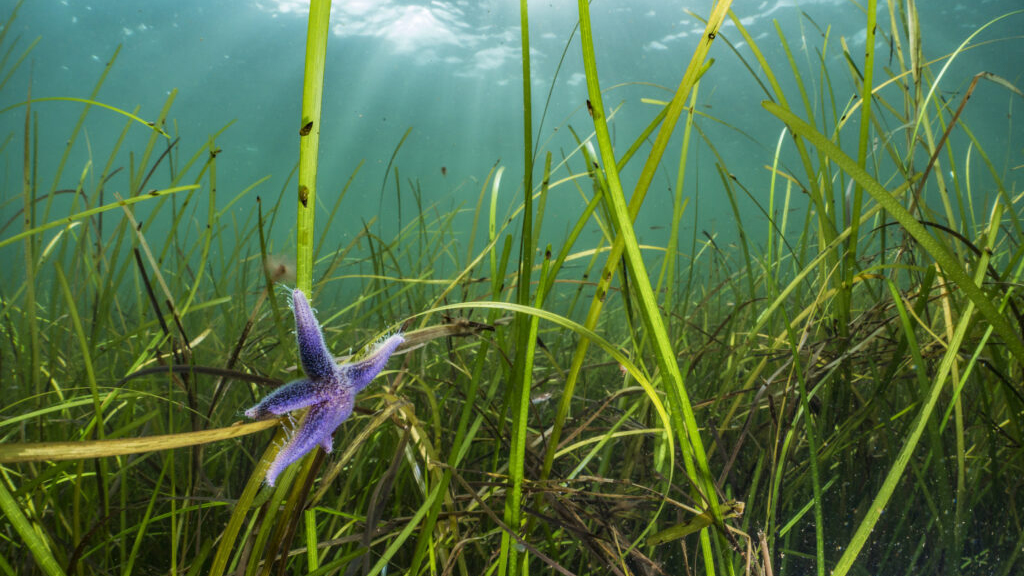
[{"xmin": 6, "ymin": 0, "xmax": 1022, "ymax": 251}]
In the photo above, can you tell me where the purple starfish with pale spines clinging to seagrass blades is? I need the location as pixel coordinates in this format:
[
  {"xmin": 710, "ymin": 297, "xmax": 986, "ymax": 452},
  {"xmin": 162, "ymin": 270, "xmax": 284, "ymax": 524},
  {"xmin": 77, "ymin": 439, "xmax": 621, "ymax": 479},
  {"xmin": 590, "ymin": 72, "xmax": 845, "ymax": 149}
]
[{"xmin": 246, "ymin": 289, "xmax": 406, "ymax": 486}]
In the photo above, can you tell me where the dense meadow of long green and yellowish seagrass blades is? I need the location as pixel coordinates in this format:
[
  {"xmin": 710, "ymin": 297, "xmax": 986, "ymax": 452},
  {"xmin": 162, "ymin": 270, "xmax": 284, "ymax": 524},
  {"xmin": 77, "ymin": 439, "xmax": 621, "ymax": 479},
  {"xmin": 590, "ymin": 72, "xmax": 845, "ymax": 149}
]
[{"xmin": 0, "ymin": 0, "xmax": 1024, "ymax": 576}]
